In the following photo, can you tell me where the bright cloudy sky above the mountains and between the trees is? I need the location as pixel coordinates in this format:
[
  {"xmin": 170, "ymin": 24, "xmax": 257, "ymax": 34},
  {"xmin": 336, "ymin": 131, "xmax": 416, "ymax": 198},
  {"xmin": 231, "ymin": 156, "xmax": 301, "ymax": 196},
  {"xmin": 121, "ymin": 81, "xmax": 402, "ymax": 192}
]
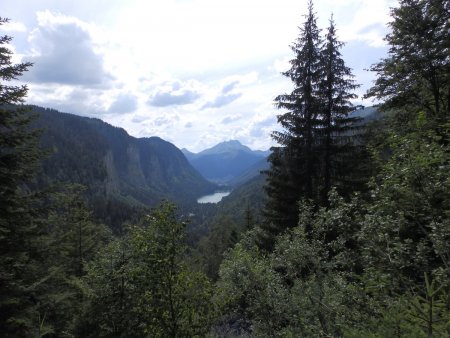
[{"xmin": 0, "ymin": 0, "xmax": 396, "ymax": 152}]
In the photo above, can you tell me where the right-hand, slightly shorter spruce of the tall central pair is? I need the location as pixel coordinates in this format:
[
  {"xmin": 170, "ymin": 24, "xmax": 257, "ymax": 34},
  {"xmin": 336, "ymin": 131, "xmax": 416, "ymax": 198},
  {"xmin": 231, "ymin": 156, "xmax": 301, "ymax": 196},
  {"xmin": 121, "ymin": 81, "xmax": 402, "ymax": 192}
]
[{"xmin": 318, "ymin": 17, "xmax": 361, "ymax": 206}]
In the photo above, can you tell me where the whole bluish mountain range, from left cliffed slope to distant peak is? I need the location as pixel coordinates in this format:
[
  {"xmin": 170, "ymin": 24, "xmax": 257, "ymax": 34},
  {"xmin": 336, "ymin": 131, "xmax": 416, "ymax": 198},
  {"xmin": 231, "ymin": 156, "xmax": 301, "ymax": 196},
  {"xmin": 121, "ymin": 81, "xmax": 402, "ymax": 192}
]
[{"xmin": 32, "ymin": 106, "xmax": 379, "ymax": 227}]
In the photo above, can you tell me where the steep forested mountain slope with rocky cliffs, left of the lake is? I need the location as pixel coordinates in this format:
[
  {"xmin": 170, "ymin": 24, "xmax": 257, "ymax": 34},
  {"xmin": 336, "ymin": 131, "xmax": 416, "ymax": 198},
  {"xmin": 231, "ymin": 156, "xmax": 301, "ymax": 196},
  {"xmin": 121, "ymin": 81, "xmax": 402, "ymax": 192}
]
[{"xmin": 33, "ymin": 107, "xmax": 215, "ymax": 206}]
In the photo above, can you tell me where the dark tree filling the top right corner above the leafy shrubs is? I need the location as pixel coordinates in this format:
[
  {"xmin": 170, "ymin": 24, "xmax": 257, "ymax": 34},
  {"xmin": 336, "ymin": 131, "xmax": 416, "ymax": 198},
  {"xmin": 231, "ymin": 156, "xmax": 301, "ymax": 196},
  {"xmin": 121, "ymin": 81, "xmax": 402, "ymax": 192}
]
[{"xmin": 366, "ymin": 0, "xmax": 450, "ymax": 124}]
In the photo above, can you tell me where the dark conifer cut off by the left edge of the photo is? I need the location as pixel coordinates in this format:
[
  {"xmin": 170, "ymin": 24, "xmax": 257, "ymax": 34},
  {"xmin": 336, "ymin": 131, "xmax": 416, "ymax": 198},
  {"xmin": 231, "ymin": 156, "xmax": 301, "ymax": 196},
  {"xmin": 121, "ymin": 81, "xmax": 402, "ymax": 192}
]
[{"xmin": 0, "ymin": 18, "xmax": 42, "ymax": 337}]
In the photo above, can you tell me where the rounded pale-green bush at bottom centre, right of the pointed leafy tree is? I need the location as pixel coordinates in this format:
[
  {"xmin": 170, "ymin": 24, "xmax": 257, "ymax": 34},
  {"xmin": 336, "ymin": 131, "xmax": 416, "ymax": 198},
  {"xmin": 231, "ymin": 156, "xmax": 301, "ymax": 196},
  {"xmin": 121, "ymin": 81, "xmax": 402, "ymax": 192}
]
[{"xmin": 214, "ymin": 240, "xmax": 289, "ymax": 336}]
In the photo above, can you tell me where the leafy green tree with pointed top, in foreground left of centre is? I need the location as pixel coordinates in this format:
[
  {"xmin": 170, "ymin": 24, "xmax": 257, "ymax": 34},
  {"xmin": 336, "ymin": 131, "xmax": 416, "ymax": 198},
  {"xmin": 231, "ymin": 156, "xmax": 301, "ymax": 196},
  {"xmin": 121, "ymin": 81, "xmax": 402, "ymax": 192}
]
[{"xmin": 80, "ymin": 203, "xmax": 213, "ymax": 337}]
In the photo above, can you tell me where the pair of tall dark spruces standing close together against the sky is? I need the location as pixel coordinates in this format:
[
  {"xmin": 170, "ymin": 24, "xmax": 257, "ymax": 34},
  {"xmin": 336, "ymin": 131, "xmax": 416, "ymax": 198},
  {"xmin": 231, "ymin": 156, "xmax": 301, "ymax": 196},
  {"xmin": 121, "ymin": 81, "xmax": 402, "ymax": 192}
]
[{"xmin": 260, "ymin": 1, "xmax": 358, "ymax": 248}]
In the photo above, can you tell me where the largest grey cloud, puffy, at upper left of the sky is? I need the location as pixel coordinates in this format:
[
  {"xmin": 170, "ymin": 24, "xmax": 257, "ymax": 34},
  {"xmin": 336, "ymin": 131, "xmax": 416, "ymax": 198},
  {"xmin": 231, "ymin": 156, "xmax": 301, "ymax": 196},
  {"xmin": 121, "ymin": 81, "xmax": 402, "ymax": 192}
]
[{"xmin": 24, "ymin": 11, "xmax": 111, "ymax": 86}]
